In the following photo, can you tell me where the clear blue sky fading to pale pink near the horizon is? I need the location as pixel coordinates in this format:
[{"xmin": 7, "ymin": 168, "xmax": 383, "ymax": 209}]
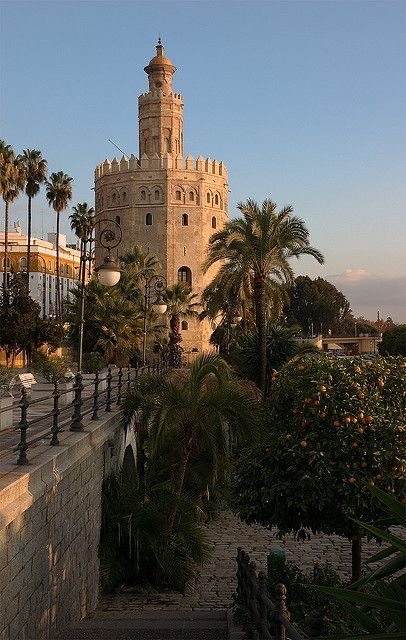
[{"xmin": 0, "ymin": 0, "xmax": 406, "ymax": 322}]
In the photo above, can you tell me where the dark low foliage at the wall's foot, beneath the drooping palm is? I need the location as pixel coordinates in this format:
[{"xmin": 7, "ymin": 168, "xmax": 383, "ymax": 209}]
[{"xmin": 100, "ymin": 476, "xmax": 209, "ymax": 592}]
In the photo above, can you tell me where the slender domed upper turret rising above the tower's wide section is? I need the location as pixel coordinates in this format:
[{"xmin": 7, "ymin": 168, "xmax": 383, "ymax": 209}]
[{"xmin": 138, "ymin": 38, "xmax": 183, "ymax": 158}]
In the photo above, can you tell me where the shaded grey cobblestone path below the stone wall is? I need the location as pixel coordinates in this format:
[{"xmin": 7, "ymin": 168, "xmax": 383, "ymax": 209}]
[{"xmin": 96, "ymin": 512, "xmax": 384, "ymax": 617}]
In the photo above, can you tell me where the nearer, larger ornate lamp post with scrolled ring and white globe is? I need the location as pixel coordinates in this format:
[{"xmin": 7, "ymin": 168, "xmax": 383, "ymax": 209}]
[{"xmin": 78, "ymin": 220, "xmax": 123, "ymax": 373}]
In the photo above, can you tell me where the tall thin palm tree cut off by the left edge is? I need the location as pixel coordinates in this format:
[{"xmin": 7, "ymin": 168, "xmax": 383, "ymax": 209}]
[{"xmin": 0, "ymin": 140, "xmax": 25, "ymax": 300}]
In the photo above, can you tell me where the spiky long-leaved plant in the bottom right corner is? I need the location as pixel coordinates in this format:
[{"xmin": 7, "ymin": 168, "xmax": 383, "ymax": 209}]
[{"xmin": 316, "ymin": 487, "xmax": 406, "ymax": 640}]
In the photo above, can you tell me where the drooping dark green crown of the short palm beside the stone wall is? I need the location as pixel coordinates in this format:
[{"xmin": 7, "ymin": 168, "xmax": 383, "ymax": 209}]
[{"xmin": 122, "ymin": 354, "xmax": 255, "ymax": 508}]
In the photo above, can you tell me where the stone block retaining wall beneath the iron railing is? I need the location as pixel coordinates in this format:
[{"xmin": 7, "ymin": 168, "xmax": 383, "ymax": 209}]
[{"xmin": 0, "ymin": 411, "xmax": 122, "ymax": 640}]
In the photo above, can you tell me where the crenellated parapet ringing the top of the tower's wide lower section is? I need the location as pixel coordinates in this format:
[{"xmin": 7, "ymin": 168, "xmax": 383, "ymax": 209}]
[{"xmin": 95, "ymin": 153, "xmax": 227, "ymax": 180}]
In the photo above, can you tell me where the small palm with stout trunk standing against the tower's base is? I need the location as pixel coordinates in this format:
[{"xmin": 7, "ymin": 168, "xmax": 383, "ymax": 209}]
[{"xmin": 164, "ymin": 282, "xmax": 199, "ymax": 368}]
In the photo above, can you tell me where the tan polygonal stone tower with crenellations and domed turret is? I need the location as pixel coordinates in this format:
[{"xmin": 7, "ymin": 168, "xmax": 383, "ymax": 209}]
[{"xmin": 95, "ymin": 40, "xmax": 228, "ymax": 352}]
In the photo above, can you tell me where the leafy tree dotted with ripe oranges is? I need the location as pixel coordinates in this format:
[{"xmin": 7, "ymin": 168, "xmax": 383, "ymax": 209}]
[{"xmin": 234, "ymin": 356, "xmax": 406, "ymax": 580}]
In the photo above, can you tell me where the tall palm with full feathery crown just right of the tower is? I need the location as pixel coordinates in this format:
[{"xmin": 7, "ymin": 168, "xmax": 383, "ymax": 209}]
[{"xmin": 204, "ymin": 199, "xmax": 324, "ymax": 396}]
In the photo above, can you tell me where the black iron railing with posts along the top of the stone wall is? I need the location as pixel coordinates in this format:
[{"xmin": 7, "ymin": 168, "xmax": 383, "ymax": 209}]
[{"xmin": 0, "ymin": 359, "xmax": 168, "ymax": 465}]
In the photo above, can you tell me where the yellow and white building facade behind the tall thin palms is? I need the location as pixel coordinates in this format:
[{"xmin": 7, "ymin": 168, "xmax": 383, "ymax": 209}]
[{"xmin": 0, "ymin": 223, "xmax": 80, "ymax": 318}]
